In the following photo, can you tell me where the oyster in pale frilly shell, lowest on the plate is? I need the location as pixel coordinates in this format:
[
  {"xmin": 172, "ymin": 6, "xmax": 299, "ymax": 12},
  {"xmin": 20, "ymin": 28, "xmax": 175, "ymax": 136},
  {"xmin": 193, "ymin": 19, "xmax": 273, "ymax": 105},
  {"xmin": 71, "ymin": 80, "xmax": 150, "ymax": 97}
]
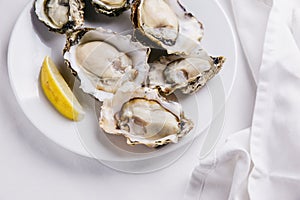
[{"xmin": 99, "ymin": 84, "xmax": 193, "ymax": 147}]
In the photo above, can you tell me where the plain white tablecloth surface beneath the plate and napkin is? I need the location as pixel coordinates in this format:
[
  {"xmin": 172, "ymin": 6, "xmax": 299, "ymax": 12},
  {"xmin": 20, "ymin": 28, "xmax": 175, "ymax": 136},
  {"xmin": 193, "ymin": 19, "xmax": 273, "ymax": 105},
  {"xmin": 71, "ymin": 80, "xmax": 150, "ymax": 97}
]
[{"xmin": 0, "ymin": 0, "xmax": 256, "ymax": 200}]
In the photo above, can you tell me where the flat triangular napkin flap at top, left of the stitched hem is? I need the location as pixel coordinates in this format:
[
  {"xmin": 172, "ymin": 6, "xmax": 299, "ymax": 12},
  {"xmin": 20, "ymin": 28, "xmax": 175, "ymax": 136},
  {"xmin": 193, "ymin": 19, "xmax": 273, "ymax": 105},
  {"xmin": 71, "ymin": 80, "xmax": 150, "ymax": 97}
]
[{"xmin": 231, "ymin": 0, "xmax": 272, "ymax": 83}]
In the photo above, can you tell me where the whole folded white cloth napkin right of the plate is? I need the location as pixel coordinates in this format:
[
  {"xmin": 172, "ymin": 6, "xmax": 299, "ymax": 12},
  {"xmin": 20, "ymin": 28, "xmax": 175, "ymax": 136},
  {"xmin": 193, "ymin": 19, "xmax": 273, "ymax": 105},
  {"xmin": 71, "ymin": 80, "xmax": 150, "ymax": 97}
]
[{"xmin": 185, "ymin": 0, "xmax": 300, "ymax": 200}]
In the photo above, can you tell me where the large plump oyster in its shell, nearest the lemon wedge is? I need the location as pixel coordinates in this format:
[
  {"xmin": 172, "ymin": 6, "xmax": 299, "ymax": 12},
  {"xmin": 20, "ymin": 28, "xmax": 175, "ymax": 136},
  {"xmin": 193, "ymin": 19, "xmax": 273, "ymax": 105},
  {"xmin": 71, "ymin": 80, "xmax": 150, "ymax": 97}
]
[{"xmin": 64, "ymin": 28, "xmax": 150, "ymax": 101}]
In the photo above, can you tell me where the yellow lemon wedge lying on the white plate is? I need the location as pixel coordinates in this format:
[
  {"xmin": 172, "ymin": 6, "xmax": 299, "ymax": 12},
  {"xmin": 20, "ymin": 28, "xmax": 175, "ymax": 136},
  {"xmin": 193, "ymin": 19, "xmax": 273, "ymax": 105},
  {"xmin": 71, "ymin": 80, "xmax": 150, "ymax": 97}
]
[{"xmin": 40, "ymin": 56, "xmax": 84, "ymax": 121}]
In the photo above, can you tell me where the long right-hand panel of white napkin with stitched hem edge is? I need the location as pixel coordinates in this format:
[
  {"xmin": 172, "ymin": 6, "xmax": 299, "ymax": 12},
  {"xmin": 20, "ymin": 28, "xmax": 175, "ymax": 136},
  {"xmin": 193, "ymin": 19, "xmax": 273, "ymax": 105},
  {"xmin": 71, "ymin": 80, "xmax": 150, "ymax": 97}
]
[{"xmin": 249, "ymin": 0, "xmax": 300, "ymax": 199}]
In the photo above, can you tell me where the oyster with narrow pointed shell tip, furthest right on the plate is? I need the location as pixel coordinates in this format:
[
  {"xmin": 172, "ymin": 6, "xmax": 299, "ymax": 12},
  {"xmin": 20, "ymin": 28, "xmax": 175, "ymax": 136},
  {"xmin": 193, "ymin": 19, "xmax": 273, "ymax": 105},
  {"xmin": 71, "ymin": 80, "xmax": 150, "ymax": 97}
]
[{"xmin": 148, "ymin": 49, "xmax": 225, "ymax": 95}]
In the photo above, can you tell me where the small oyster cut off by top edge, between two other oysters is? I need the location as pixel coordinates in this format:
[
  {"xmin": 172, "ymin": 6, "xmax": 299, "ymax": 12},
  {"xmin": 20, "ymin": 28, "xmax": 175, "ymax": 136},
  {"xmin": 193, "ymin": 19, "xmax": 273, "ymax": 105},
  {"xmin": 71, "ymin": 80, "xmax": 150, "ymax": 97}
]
[{"xmin": 91, "ymin": 0, "xmax": 130, "ymax": 16}]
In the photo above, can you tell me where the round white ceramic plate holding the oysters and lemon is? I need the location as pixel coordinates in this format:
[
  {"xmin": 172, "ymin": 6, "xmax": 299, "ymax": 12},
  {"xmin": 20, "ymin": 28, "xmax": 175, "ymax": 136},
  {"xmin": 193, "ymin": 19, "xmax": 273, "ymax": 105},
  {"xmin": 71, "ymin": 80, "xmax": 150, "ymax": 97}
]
[{"xmin": 8, "ymin": 0, "xmax": 236, "ymax": 171}]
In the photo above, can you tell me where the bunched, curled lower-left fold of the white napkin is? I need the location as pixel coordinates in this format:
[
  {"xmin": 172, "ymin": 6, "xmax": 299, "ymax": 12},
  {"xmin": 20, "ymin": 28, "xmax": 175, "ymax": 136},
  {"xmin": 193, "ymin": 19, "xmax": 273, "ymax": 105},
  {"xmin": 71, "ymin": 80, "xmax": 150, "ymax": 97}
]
[{"xmin": 185, "ymin": 129, "xmax": 252, "ymax": 200}]
